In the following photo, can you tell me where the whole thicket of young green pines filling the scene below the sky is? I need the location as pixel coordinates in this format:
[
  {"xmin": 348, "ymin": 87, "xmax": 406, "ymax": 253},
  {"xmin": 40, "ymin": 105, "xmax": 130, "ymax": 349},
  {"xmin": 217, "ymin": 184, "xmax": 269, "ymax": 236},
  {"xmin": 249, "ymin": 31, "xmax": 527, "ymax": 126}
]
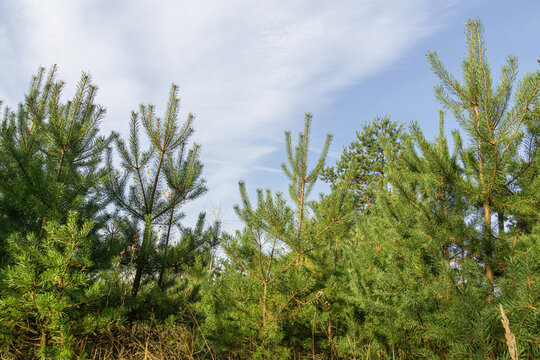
[{"xmin": 0, "ymin": 21, "xmax": 540, "ymax": 359}]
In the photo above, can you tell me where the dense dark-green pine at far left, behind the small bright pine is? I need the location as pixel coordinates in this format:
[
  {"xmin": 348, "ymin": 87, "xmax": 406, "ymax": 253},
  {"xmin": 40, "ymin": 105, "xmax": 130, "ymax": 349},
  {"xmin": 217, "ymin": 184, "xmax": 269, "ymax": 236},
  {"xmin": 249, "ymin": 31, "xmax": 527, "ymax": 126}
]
[{"xmin": 0, "ymin": 67, "xmax": 115, "ymax": 266}]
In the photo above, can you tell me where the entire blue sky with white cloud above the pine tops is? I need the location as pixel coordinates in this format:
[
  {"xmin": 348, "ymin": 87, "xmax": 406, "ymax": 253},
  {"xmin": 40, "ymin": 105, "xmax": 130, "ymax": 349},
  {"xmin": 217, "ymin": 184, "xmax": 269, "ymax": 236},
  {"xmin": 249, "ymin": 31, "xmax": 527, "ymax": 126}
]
[{"xmin": 0, "ymin": 0, "xmax": 540, "ymax": 230}]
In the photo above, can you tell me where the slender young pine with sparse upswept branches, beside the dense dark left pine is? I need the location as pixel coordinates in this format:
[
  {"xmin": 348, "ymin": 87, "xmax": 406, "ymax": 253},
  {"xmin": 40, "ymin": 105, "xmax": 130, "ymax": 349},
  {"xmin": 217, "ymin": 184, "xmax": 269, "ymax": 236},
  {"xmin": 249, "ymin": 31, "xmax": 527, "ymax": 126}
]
[{"xmin": 106, "ymin": 85, "xmax": 206, "ymax": 297}]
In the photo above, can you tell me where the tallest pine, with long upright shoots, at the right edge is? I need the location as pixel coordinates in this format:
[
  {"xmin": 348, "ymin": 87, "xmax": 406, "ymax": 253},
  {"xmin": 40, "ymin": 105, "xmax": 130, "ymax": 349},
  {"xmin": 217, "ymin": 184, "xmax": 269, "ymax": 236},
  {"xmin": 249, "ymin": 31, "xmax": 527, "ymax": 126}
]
[{"xmin": 427, "ymin": 20, "xmax": 540, "ymax": 284}]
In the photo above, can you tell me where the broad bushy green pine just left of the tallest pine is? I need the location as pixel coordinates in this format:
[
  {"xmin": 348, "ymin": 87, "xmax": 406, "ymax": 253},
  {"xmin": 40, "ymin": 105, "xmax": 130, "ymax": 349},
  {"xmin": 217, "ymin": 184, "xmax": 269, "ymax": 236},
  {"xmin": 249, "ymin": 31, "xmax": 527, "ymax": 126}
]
[{"xmin": 349, "ymin": 114, "xmax": 474, "ymax": 358}]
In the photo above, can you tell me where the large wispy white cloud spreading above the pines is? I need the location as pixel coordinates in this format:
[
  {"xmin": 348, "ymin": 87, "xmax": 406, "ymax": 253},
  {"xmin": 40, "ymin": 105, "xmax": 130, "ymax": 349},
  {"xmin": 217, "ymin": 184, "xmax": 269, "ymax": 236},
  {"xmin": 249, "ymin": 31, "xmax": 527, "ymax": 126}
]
[{"xmin": 0, "ymin": 0, "xmax": 458, "ymax": 231}]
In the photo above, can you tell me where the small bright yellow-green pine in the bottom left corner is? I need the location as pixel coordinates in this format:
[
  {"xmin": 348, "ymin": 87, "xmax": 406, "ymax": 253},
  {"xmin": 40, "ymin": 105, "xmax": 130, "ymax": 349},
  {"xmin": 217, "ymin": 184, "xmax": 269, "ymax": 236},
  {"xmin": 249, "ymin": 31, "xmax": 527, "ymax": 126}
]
[{"xmin": 0, "ymin": 213, "xmax": 116, "ymax": 359}]
